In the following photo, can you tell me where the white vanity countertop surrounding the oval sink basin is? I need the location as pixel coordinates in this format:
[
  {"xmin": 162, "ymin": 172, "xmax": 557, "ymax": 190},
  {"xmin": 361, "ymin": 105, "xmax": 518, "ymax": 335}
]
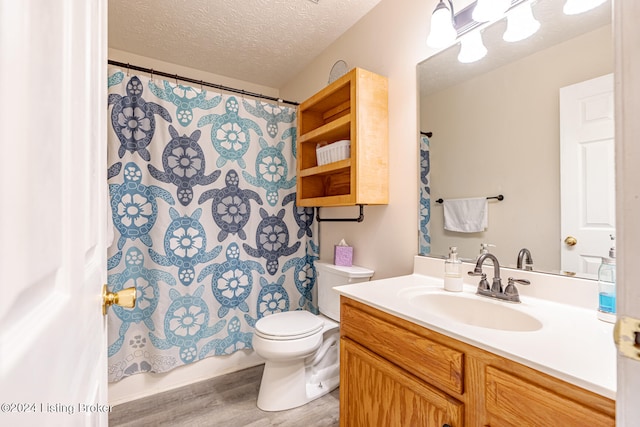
[{"xmin": 334, "ymin": 266, "xmax": 616, "ymax": 400}]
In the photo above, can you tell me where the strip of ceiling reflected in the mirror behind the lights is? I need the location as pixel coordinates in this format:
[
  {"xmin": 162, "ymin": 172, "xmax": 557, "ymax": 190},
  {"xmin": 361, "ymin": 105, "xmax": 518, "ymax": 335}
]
[{"xmin": 418, "ymin": 0, "xmax": 611, "ymax": 96}]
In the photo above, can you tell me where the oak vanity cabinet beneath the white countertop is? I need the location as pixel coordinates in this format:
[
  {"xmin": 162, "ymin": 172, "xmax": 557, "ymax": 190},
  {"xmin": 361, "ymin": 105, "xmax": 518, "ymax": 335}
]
[{"xmin": 340, "ymin": 296, "xmax": 615, "ymax": 427}]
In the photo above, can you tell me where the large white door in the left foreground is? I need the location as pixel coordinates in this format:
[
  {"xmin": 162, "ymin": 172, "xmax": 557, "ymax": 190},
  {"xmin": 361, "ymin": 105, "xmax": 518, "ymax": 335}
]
[{"xmin": 0, "ymin": 0, "xmax": 108, "ymax": 426}]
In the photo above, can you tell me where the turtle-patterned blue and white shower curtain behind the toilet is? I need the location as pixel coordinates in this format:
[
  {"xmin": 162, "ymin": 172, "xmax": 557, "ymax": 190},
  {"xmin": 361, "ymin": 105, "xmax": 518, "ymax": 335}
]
[{"xmin": 107, "ymin": 69, "xmax": 318, "ymax": 382}]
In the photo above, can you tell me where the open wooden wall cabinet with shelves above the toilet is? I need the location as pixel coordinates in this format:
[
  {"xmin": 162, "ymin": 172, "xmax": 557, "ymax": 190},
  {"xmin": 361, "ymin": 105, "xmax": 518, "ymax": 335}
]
[{"xmin": 296, "ymin": 68, "xmax": 389, "ymax": 207}]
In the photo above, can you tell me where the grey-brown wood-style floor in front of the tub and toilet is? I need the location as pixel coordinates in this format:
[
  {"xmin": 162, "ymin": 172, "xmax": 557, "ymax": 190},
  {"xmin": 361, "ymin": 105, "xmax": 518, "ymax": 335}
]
[{"xmin": 109, "ymin": 365, "xmax": 339, "ymax": 427}]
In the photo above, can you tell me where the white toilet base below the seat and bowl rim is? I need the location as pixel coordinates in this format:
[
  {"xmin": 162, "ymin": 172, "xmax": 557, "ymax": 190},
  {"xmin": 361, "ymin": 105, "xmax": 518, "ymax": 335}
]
[{"xmin": 257, "ymin": 334, "xmax": 340, "ymax": 412}]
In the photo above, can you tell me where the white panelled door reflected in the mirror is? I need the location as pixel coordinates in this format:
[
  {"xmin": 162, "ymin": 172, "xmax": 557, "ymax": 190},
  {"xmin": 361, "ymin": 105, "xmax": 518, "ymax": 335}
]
[{"xmin": 560, "ymin": 74, "xmax": 616, "ymax": 277}]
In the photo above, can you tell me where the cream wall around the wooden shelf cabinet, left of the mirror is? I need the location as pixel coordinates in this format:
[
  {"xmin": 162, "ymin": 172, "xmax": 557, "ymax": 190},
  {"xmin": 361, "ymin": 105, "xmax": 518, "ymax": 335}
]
[{"xmin": 280, "ymin": 0, "xmax": 437, "ymax": 279}]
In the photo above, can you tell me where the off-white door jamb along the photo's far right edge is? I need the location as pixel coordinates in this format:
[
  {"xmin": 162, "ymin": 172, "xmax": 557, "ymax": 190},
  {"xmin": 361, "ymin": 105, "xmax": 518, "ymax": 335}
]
[{"xmin": 613, "ymin": 1, "xmax": 640, "ymax": 427}]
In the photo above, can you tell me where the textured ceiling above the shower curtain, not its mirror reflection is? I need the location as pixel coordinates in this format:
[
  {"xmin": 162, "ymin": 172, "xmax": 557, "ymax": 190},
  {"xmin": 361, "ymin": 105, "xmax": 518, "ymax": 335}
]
[{"xmin": 109, "ymin": 0, "xmax": 380, "ymax": 88}]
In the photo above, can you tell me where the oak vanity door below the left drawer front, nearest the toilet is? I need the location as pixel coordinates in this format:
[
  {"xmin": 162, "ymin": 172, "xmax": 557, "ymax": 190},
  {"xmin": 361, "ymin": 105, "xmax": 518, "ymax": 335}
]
[{"xmin": 340, "ymin": 338, "xmax": 464, "ymax": 427}]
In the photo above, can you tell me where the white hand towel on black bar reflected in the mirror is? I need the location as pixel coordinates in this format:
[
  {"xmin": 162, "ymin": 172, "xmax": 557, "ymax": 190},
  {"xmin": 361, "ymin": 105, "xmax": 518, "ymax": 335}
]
[{"xmin": 443, "ymin": 197, "xmax": 489, "ymax": 233}]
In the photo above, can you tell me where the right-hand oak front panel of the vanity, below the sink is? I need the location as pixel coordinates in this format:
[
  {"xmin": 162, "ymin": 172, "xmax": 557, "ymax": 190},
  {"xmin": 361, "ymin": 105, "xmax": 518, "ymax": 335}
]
[{"xmin": 485, "ymin": 366, "xmax": 615, "ymax": 427}]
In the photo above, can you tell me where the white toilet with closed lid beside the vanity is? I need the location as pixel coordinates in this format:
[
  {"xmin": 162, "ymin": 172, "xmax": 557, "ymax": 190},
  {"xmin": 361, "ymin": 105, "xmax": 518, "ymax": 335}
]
[{"xmin": 253, "ymin": 261, "xmax": 373, "ymax": 411}]
